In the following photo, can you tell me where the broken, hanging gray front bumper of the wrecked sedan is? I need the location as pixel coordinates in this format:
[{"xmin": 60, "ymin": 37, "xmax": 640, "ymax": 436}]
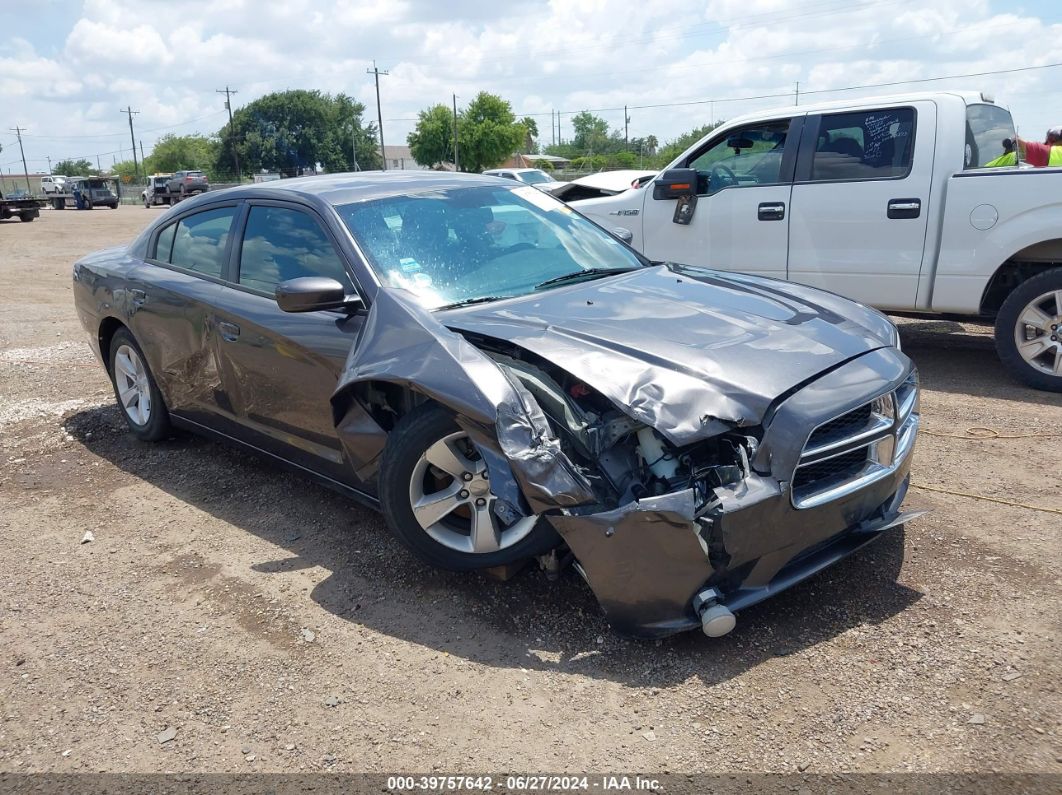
[{"xmin": 550, "ymin": 349, "xmax": 917, "ymax": 638}]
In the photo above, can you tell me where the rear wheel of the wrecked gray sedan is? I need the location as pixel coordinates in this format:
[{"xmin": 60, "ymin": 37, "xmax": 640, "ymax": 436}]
[{"xmin": 107, "ymin": 328, "xmax": 170, "ymax": 442}]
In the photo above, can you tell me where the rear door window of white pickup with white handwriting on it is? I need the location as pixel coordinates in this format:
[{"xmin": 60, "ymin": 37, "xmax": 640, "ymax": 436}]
[{"xmin": 811, "ymin": 107, "xmax": 914, "ymax": 182}]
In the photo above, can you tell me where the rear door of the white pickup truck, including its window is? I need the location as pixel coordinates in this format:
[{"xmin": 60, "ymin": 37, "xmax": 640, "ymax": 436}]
[{"xmin": 789, "ymin": 102, "xmax": 937, "ymax": 309}]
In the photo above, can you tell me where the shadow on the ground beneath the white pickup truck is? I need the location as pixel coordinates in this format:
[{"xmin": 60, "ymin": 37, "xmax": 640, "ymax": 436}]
[{"xmin": 900, "ymin": 319, "xmax": 1059, "ymax": 405}]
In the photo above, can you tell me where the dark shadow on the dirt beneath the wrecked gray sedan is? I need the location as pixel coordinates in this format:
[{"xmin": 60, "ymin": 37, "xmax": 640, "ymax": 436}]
[{"xmin": 65, "ymin": 407, "xmax": 922, "ymax": 687}]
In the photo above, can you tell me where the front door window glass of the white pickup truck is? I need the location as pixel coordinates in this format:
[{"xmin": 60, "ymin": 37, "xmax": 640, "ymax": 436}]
[{"xmin": 686, "ymin": 119, "xmax": 789, "ymax": 195}]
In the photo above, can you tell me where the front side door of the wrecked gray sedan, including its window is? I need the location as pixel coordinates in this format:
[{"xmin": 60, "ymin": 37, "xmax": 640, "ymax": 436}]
[{"xmin": 216, "ymin": 201, "xmax": 364, "ymax": 486}]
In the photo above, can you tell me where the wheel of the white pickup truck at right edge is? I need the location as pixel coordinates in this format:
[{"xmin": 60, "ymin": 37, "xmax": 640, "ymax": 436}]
[{"xmin": 995, "ymin": 267, "xmax": 1062, "ymax": 392}]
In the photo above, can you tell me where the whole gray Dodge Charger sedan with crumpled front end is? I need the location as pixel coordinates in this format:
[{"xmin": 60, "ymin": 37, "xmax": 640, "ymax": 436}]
[{"xmin": 73, "ymin": 172, "xmax": 919, "ymax": 637}]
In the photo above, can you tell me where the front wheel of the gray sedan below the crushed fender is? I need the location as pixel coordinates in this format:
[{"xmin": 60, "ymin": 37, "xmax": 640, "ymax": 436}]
[{"xmin": 379, "ymin": 403, "xmax": 560, "ymax": 571}]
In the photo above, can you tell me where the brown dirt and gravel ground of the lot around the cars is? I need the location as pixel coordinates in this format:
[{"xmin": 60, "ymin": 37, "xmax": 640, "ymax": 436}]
[{"xmin": 0, "ymin": 207, "xmax": 1062, "ymax": 773}]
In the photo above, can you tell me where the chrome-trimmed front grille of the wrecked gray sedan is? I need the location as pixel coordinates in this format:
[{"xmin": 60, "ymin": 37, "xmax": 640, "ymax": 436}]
[{"xmin": 792, "ymin": 371, "xmax": 919, "ymax": 508}]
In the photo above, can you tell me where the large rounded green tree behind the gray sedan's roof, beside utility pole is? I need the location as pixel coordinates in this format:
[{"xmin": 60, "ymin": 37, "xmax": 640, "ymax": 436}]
[{"xmin": 215, "ymin": 89, "xmax": 380, "ymax": 173}]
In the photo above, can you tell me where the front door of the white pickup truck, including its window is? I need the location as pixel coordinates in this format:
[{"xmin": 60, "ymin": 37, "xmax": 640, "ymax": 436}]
[{"xmin": 620, "ymin": 116, "xmax": 804, "ymax": 279}]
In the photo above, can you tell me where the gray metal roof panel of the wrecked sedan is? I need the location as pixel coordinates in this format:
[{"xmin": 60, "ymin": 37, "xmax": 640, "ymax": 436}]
[{"xmin": 203, "ymin": 171, "xmax": 512, "ymax": 205}]
